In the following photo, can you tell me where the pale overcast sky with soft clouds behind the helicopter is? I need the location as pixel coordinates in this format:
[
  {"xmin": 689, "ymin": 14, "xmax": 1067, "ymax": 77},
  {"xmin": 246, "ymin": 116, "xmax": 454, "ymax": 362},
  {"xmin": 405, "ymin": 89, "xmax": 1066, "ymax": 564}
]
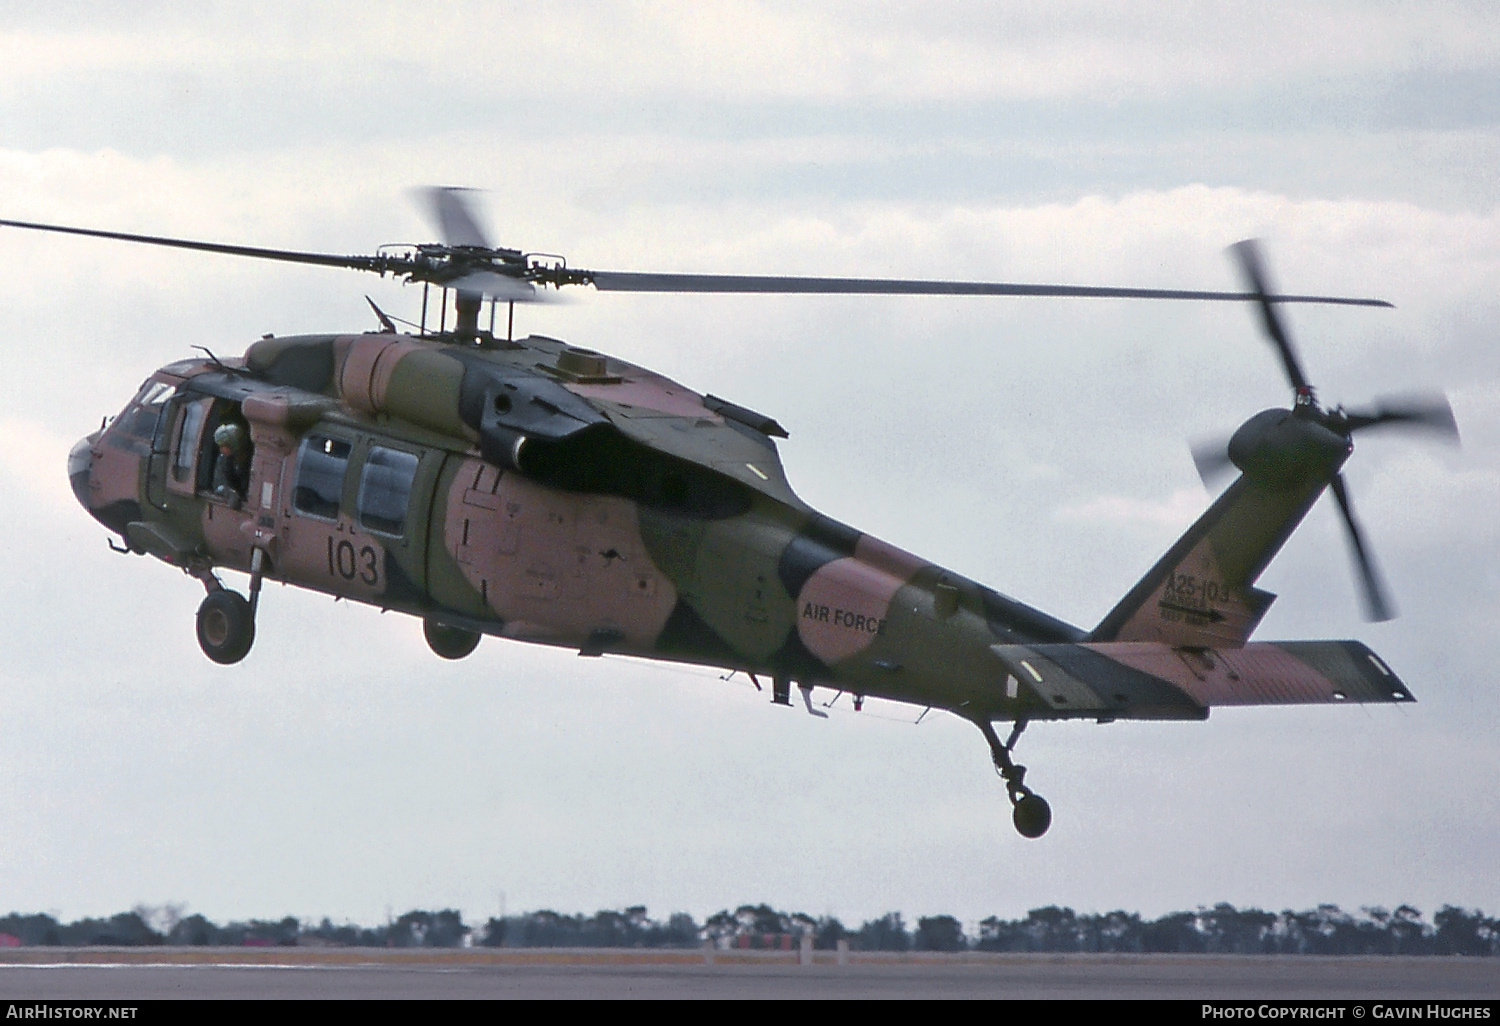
[{"xmin": 0, "ymin": 0, "xmax": 1500, "ymax": 924}]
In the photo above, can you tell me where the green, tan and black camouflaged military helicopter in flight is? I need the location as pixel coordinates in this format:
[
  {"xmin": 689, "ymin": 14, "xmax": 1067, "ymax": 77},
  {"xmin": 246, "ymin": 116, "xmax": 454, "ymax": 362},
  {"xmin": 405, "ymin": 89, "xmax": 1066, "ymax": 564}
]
[{"xmin": 0, "ymin": 189, "xmax": 1458, "ymax": 837}]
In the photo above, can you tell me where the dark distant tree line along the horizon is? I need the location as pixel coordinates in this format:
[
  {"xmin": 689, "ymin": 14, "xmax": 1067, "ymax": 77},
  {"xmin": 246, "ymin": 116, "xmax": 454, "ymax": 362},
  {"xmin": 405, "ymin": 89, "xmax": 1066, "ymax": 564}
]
[{"xmin": 0, "ymin": 903, "xmax": 1500, "ymax": 956}]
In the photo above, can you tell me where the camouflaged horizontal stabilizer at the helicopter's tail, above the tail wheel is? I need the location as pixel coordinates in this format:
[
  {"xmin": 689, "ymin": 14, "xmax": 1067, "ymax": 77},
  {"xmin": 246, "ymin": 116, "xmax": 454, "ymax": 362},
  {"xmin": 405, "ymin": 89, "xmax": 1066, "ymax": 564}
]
[{"xmin": 990, "ymin": 641, "xmax": 1415, "ymax": 720}]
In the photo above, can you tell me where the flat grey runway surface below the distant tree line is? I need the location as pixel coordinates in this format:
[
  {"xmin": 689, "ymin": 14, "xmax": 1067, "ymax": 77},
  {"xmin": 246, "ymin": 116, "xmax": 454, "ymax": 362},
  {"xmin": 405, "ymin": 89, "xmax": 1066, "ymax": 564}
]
[{"xmin": 0, "ymin": 948, "xmax": 1500, "ymax": 1001}]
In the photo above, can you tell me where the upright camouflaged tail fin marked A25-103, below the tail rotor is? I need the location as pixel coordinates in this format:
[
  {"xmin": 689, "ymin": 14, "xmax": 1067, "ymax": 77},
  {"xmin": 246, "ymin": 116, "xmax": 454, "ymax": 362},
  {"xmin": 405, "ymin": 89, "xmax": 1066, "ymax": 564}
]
[{"xmin": 1089, "ymin": 474, "xmax": 1328, "ymax": 648}]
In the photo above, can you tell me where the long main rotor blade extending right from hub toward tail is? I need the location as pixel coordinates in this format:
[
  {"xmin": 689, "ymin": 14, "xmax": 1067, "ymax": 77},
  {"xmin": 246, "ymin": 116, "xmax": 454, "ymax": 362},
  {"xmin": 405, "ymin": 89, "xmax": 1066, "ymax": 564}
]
[{"xmin": 576, "ymin": 272, "xmax": 1391, "ymax": 306}]
